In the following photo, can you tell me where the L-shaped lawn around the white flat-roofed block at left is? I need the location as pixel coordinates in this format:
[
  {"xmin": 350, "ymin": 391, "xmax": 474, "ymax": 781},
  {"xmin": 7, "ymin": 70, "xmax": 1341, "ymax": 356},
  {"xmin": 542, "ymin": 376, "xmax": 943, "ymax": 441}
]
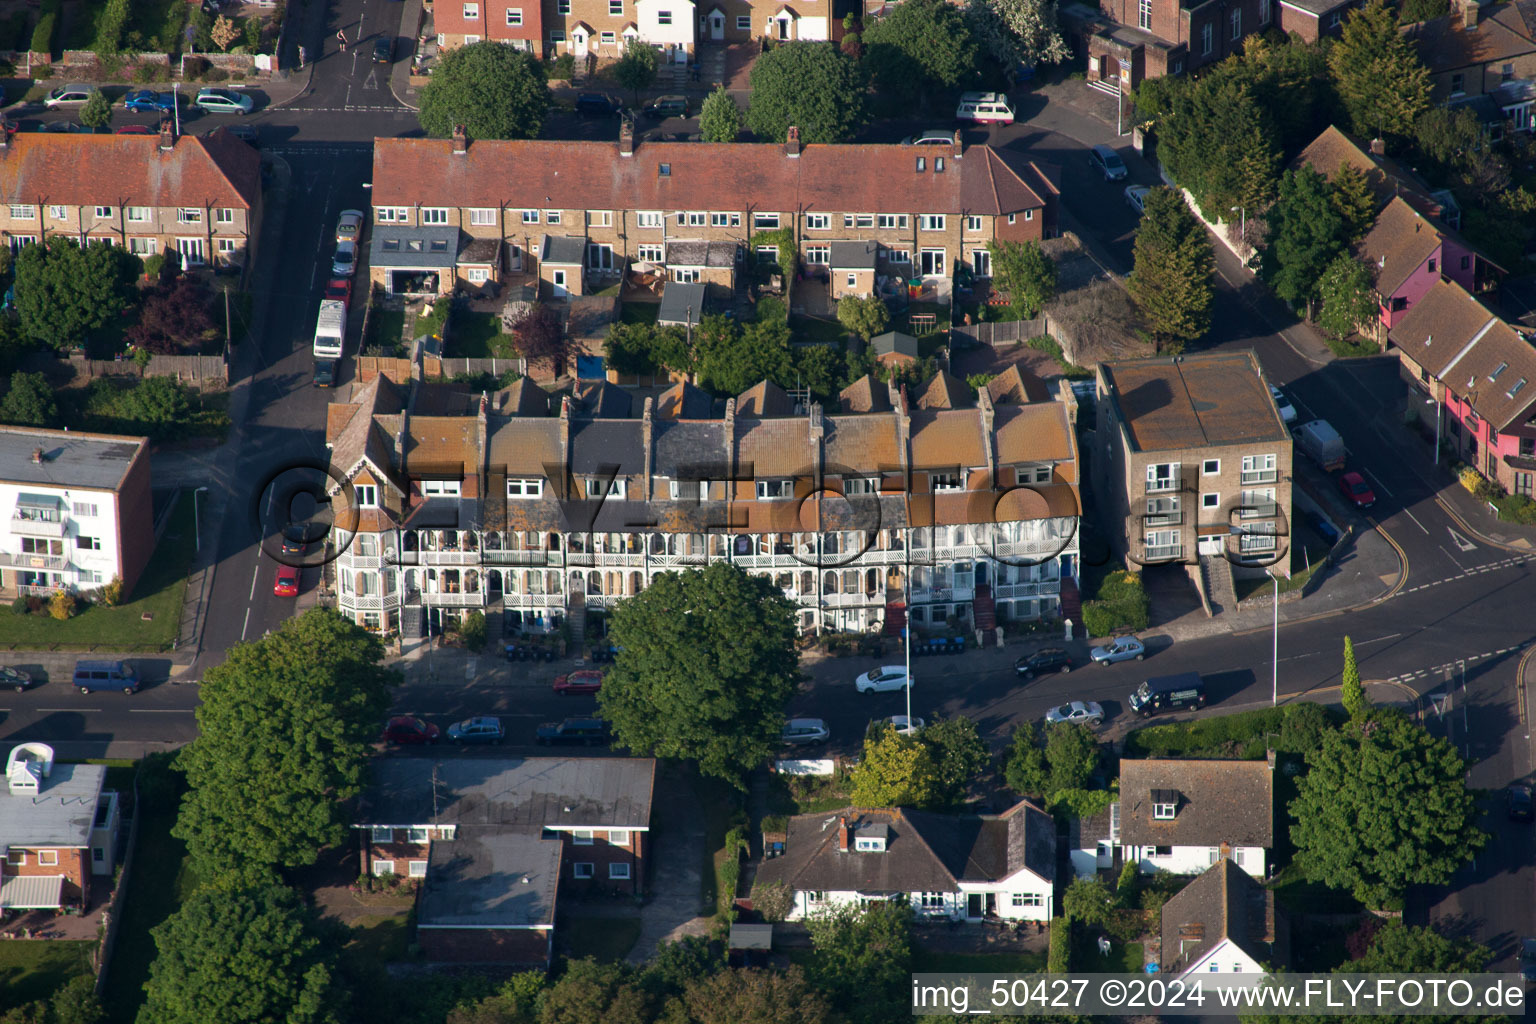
[{"xmin": 0, "ymin": 491, "xmax": 195, "ymax": 652}]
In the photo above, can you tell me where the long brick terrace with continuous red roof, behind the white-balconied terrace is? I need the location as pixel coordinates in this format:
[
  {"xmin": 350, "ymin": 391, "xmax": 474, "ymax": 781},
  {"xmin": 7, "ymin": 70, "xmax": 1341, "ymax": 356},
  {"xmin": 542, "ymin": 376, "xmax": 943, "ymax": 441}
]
[{"xmin": 369, "ymin": 123, "xmax": 1058, "ymax": 298}]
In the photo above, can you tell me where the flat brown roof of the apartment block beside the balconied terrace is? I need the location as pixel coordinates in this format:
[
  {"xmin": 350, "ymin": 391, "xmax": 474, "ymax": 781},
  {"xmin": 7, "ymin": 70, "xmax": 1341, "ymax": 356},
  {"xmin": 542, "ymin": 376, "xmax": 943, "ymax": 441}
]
[{"xmin": 1098, "ymin": 350, "xmax": 1290, "ymax": 451}]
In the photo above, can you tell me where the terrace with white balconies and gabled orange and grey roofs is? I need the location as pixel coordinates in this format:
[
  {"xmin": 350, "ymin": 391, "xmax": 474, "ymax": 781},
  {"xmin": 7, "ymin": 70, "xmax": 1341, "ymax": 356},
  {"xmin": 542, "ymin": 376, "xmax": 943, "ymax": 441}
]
[{"xmin": 327, "ymin": 367, "xmax": 1080, "ymax": 636}]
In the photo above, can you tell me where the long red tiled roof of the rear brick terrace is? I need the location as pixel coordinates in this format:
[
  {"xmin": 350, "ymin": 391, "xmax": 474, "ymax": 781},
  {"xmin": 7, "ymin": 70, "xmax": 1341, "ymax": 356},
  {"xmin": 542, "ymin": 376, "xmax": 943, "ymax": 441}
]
[{"xmin": 373, "ymin": 138, "xmax": 1044, "ymax": 213}]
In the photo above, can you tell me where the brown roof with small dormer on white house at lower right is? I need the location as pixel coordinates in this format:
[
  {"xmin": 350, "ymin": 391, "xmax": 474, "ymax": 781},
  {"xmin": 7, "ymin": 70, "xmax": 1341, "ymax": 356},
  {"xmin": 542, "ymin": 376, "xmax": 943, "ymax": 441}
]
[{"xmin": 1120, "ymin": 758, "xmax": 1275, "ymax": 847}]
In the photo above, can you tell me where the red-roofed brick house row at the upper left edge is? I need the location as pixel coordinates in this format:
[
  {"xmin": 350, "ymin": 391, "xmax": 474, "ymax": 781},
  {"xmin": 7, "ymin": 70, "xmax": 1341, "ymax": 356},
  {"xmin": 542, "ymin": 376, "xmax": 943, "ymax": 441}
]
[{"xmin": 0, "ymin": 124, "xmax": 261, "ymax": 274}]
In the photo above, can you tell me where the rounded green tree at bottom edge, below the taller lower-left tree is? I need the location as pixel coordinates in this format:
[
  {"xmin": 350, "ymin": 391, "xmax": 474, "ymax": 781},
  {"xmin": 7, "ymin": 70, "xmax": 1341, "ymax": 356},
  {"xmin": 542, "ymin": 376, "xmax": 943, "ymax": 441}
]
[{"xmin": 138, "ymin": 886, "xmax": 346, "ymax": 1024}]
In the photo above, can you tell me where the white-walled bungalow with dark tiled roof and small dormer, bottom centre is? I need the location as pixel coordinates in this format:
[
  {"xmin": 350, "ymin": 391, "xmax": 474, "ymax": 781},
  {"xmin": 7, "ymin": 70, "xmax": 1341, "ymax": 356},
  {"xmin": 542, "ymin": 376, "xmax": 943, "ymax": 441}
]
[{"xmin": 754, "ymin": 800, "xmax": 1055, "ymax": 921}]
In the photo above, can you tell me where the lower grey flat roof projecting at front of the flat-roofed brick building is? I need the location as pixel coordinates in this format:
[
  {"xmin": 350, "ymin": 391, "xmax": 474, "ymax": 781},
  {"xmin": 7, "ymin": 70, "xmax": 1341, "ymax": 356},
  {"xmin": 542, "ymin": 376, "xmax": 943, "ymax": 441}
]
[{"xmin": 416, "ymin": 829, "xmax": 561, "ymax": 929}]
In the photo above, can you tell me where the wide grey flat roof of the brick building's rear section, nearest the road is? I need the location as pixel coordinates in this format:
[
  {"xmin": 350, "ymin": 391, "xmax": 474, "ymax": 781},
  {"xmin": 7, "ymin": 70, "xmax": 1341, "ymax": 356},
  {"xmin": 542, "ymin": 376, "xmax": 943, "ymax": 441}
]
[{"xmin": 353, "ymin": 757, "xmax": 656, "ymax": 829}]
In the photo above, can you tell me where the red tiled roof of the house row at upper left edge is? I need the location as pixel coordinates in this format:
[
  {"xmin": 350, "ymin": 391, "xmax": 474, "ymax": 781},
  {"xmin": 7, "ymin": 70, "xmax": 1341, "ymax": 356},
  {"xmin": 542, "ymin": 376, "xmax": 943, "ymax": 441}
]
[{"xmin": 0, "ymin": 132, "xmax": 261, "ymax": 209}]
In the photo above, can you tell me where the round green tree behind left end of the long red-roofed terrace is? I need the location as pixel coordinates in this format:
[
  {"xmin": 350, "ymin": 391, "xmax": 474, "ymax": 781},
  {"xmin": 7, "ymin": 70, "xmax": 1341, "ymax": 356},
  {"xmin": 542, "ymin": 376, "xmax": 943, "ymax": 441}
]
[{"xmin": 419, "ymin": 41, "xmax": 550, "ymax": 138}]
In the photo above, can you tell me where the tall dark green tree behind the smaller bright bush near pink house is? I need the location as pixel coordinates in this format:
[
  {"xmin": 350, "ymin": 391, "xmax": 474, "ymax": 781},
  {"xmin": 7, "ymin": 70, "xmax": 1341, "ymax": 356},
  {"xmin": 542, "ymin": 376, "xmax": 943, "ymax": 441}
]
[{"xmin": 1264, "ymin": 167, "xmax": 1346, "ymax": 316}]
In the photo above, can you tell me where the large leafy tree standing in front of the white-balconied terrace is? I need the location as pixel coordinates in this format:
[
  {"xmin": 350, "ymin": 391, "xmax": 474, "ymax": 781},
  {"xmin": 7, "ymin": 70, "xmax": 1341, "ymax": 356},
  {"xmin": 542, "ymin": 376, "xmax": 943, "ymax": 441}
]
[{"xmin": 598, "ymin": 562, "xmax": 800, "ymax": 785}]
